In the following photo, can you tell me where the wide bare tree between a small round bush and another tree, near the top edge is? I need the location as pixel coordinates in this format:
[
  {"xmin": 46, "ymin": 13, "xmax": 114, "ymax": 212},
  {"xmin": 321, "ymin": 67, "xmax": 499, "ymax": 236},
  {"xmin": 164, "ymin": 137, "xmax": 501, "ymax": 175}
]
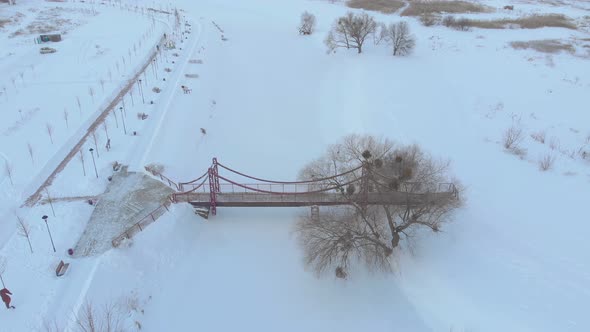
[{"xmin": 324, "ymin": 12, "xmax": 377, "ymax": 53}]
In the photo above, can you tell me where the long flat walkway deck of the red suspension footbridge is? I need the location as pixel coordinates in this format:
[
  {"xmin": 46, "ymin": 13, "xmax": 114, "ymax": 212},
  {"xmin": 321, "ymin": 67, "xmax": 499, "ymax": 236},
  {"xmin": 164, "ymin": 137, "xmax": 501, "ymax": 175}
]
[{"xmin": 175, "ymin": 192, "xmax": 454, "ymax": 207}]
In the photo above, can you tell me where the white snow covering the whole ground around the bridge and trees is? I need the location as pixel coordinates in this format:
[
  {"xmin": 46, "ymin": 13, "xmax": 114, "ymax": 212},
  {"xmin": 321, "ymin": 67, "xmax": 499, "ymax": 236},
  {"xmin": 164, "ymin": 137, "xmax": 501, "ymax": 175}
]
[{"xmin": 0, "ymin": 0, "xmax": 590, "ymax": 332}]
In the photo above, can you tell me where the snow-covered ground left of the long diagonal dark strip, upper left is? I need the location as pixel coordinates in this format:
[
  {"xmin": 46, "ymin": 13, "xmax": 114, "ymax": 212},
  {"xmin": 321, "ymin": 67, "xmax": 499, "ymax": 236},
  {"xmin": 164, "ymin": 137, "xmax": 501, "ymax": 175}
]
[{"xmin": 0, "ymin": 3, "xmax": 166, "ymax": 241}]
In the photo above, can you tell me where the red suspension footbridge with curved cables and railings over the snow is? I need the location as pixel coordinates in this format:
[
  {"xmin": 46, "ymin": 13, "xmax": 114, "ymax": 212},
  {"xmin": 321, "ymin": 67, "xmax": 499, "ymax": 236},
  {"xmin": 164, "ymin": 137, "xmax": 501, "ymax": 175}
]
[{"xmin": 159, "ymin": 158, "xmax": 457, "ymax": 215}]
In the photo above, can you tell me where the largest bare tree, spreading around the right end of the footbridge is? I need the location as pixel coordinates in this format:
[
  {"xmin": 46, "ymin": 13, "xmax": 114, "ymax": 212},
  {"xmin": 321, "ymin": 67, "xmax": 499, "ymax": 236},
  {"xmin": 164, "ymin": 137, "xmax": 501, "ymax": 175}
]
[{"xmin": 296, "ymin": 135, "xmax": 460, "ymax": 278}]
